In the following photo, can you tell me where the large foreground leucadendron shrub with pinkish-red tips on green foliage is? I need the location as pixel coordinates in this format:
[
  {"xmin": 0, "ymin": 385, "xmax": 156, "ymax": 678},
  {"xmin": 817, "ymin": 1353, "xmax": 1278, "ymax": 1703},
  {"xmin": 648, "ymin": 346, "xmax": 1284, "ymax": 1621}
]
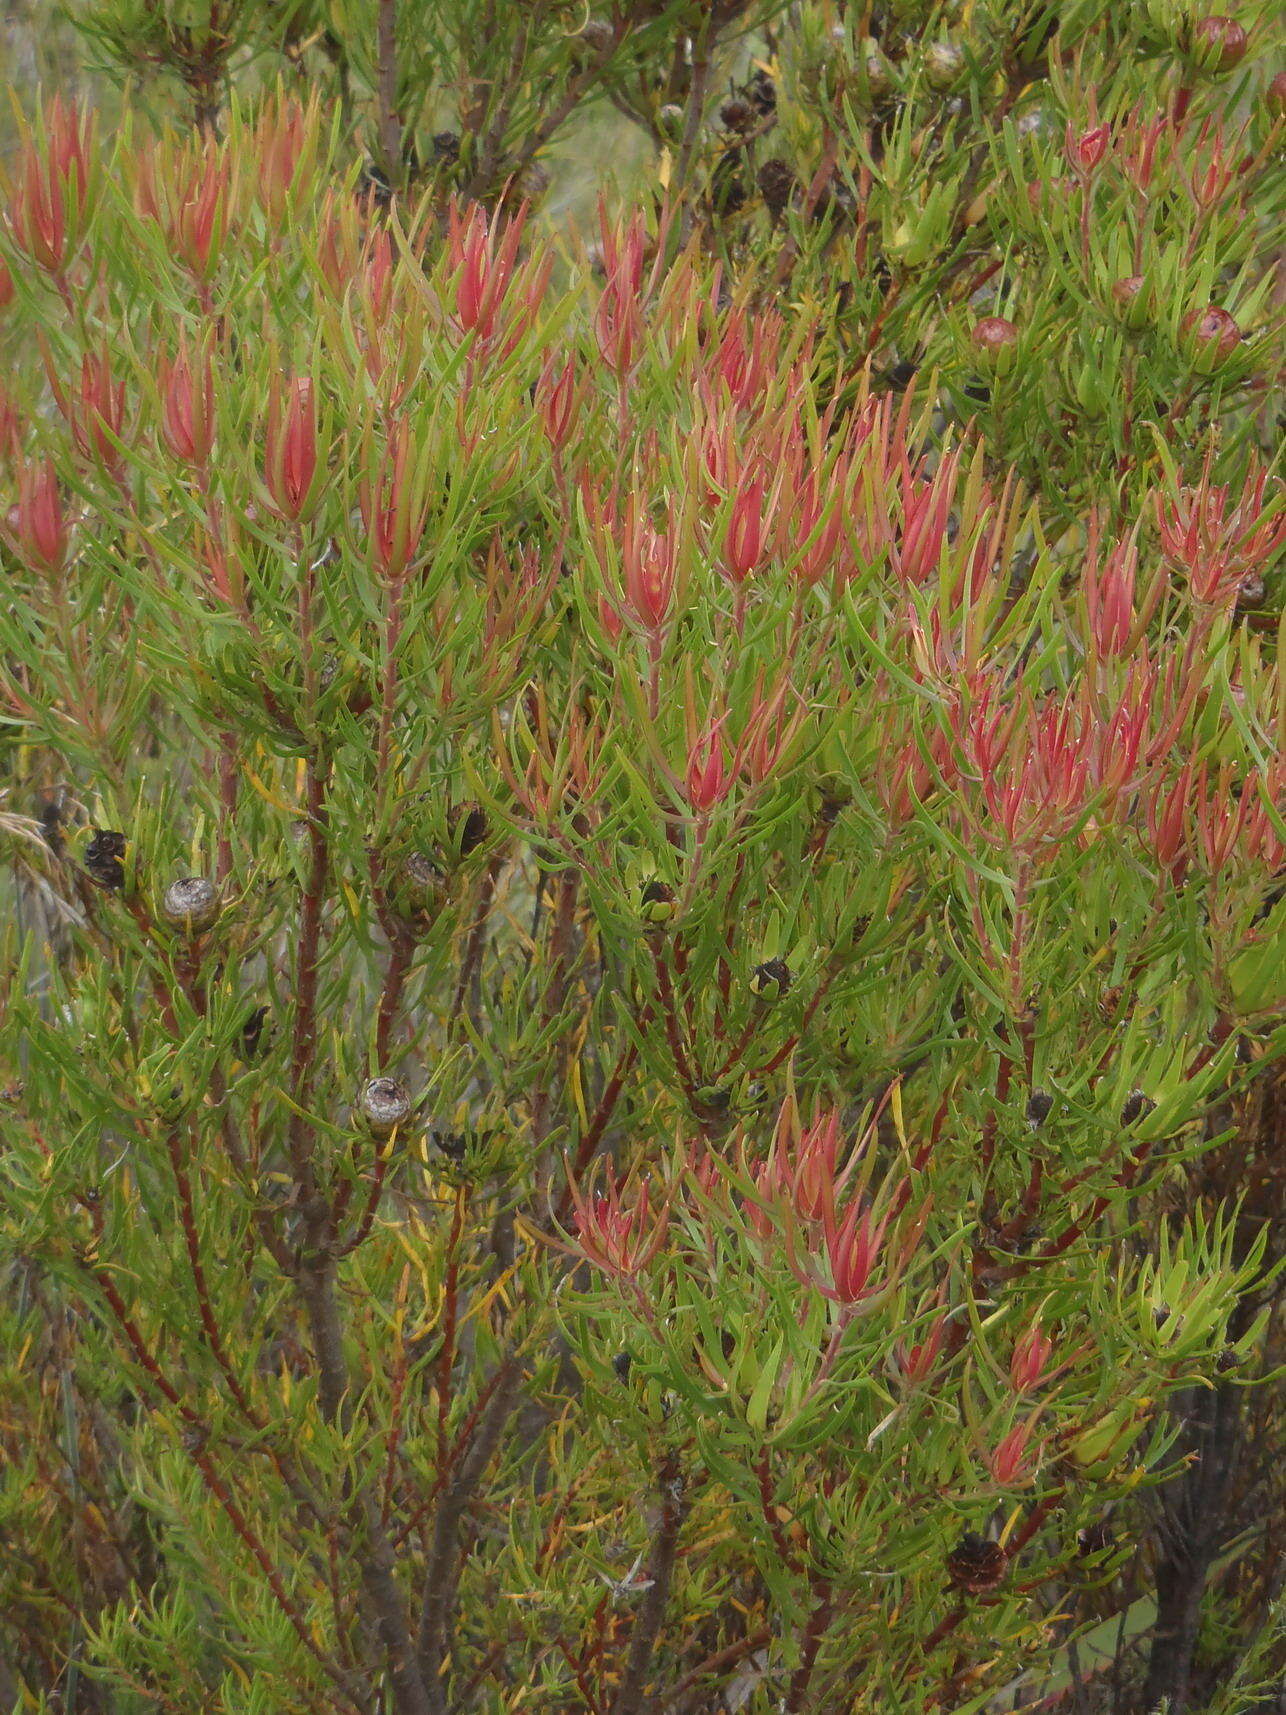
[{"xmin": 0, "ymin": 43, "xmax": 1286, "ymax": 1715}]
